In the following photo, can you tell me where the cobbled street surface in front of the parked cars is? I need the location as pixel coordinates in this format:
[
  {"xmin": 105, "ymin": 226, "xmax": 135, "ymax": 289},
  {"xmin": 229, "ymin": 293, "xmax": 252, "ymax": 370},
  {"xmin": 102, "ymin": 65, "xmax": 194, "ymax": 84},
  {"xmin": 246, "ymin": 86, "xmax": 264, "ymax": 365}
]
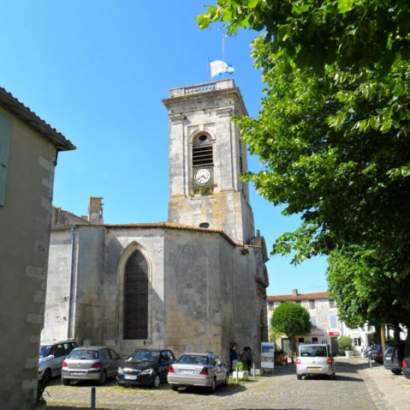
[{"xmin": 44, "ymin": 360, "xmax": 383, "ymax": 410}]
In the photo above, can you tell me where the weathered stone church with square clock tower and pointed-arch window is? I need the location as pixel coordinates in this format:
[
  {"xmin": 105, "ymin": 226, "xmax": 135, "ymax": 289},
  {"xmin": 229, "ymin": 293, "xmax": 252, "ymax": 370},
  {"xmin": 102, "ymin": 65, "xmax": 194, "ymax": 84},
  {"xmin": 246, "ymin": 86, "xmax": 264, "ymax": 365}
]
[{"xmin": 42, "ymin": 80, "xmax": 268, "ymax": 360}]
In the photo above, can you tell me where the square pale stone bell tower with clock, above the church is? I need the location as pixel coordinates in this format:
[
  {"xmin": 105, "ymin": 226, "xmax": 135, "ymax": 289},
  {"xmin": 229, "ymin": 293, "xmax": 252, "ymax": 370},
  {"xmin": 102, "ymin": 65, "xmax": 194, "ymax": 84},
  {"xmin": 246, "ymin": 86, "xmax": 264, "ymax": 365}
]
[{"xmin": 164, "ymin": 80, "xmax": 254, "ymax": 243}]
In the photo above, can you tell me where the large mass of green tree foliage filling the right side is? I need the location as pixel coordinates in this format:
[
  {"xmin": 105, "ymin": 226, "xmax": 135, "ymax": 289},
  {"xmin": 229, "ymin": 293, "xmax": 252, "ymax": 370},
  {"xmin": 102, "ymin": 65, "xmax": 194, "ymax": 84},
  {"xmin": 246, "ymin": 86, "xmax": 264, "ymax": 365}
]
[{"xmin": 198, "ymin": 0, "xmax": 410, "ymax": 330}]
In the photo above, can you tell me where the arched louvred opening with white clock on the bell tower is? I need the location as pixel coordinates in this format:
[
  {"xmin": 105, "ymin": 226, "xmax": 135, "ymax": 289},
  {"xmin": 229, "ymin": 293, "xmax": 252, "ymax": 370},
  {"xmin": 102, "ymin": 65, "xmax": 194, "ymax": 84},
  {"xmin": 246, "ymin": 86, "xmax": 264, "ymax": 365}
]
[{"xmin": 192, "ymin": 134, "xmax": 214, "ymax": 195}]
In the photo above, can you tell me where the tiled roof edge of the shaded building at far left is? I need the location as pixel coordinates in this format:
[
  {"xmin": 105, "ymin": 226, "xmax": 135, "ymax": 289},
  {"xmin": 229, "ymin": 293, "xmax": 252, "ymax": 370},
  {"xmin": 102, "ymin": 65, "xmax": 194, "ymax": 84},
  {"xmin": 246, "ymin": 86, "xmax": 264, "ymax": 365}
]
[{"xmin": 0, "ymin": 87, "xmax": 75, "ymax": 151}]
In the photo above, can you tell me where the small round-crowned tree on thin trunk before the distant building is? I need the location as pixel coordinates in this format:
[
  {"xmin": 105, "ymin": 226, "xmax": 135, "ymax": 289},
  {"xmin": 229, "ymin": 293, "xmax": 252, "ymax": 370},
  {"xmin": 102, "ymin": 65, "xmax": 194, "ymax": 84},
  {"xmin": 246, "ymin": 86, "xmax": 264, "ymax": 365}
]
[{"xmin": 271, "ymin": 302, "xmax": 311, "ymax": 353}]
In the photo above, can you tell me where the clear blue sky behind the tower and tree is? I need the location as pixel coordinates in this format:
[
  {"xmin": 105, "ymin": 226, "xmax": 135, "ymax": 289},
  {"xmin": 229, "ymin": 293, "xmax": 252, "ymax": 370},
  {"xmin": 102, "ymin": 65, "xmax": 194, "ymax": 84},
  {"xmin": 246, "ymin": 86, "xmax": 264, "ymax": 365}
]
[{"xmin": 0, "ymin": 0, "xmax": 326, "ymax": 294}]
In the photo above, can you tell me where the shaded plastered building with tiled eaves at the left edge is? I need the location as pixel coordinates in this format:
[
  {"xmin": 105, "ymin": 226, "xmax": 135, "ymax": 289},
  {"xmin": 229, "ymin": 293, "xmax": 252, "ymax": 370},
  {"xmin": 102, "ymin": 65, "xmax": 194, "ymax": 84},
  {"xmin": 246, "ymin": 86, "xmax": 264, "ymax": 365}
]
[{"xmin": 0, "ymin": 88, "xmax": 75, "ymax": 410}]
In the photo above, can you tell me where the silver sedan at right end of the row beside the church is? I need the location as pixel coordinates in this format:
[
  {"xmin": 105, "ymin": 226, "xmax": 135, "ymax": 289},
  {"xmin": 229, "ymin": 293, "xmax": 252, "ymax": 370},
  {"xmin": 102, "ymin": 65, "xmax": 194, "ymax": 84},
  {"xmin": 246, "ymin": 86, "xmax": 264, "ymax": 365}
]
[{"xmin": 168, "ymin": 353, "xmax": 229, "ymax": 393}]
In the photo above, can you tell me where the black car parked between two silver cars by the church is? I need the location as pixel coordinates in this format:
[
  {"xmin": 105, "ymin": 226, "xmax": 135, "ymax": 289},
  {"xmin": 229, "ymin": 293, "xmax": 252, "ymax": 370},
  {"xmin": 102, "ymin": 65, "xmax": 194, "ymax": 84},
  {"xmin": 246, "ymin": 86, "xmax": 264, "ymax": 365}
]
[{"xmin": 117, "ymin": 349, "xmax": 175, "ymax": 388}]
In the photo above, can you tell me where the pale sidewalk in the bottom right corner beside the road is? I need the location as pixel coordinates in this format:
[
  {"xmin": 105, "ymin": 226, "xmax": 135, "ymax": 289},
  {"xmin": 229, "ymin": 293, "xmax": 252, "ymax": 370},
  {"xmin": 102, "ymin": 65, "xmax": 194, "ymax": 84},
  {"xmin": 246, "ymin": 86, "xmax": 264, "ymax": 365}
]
[{"xmin": 353, "ymin": 359, "xmax": 410, "ymax": 410}]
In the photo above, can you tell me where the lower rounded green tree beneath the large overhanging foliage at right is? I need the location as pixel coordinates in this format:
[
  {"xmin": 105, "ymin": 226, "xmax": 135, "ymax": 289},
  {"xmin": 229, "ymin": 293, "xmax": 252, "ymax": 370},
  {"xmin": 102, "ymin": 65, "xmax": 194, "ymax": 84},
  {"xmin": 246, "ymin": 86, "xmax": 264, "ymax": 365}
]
[{"xmin": 328, "ymin": 246, "xmax": 410, "ymax": 336}]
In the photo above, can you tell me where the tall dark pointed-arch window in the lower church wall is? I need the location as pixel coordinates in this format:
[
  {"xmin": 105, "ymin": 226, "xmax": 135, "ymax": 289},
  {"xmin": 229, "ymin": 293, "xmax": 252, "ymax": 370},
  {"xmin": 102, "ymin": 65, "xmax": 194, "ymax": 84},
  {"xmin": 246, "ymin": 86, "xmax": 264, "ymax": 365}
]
[{"xmin": 123, "ymin": 250, "xmax": 148, "ymax": 339}]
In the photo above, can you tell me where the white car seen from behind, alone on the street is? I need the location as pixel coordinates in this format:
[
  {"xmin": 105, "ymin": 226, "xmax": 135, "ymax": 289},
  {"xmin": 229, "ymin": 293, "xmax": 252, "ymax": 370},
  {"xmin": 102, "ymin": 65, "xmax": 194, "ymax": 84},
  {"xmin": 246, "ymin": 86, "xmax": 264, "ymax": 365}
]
[{"xmin": 296, "ymin": 344, "xmax": 336, "ymax": 380}]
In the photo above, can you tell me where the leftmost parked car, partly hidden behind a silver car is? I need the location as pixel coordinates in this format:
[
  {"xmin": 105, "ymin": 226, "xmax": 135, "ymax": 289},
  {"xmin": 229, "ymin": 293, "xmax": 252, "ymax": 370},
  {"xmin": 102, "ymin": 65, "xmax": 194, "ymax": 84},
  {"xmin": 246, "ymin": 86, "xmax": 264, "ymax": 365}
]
[{"xmin": 38, "ymin": 340, "xmax": 78, "ymax": 386}]
